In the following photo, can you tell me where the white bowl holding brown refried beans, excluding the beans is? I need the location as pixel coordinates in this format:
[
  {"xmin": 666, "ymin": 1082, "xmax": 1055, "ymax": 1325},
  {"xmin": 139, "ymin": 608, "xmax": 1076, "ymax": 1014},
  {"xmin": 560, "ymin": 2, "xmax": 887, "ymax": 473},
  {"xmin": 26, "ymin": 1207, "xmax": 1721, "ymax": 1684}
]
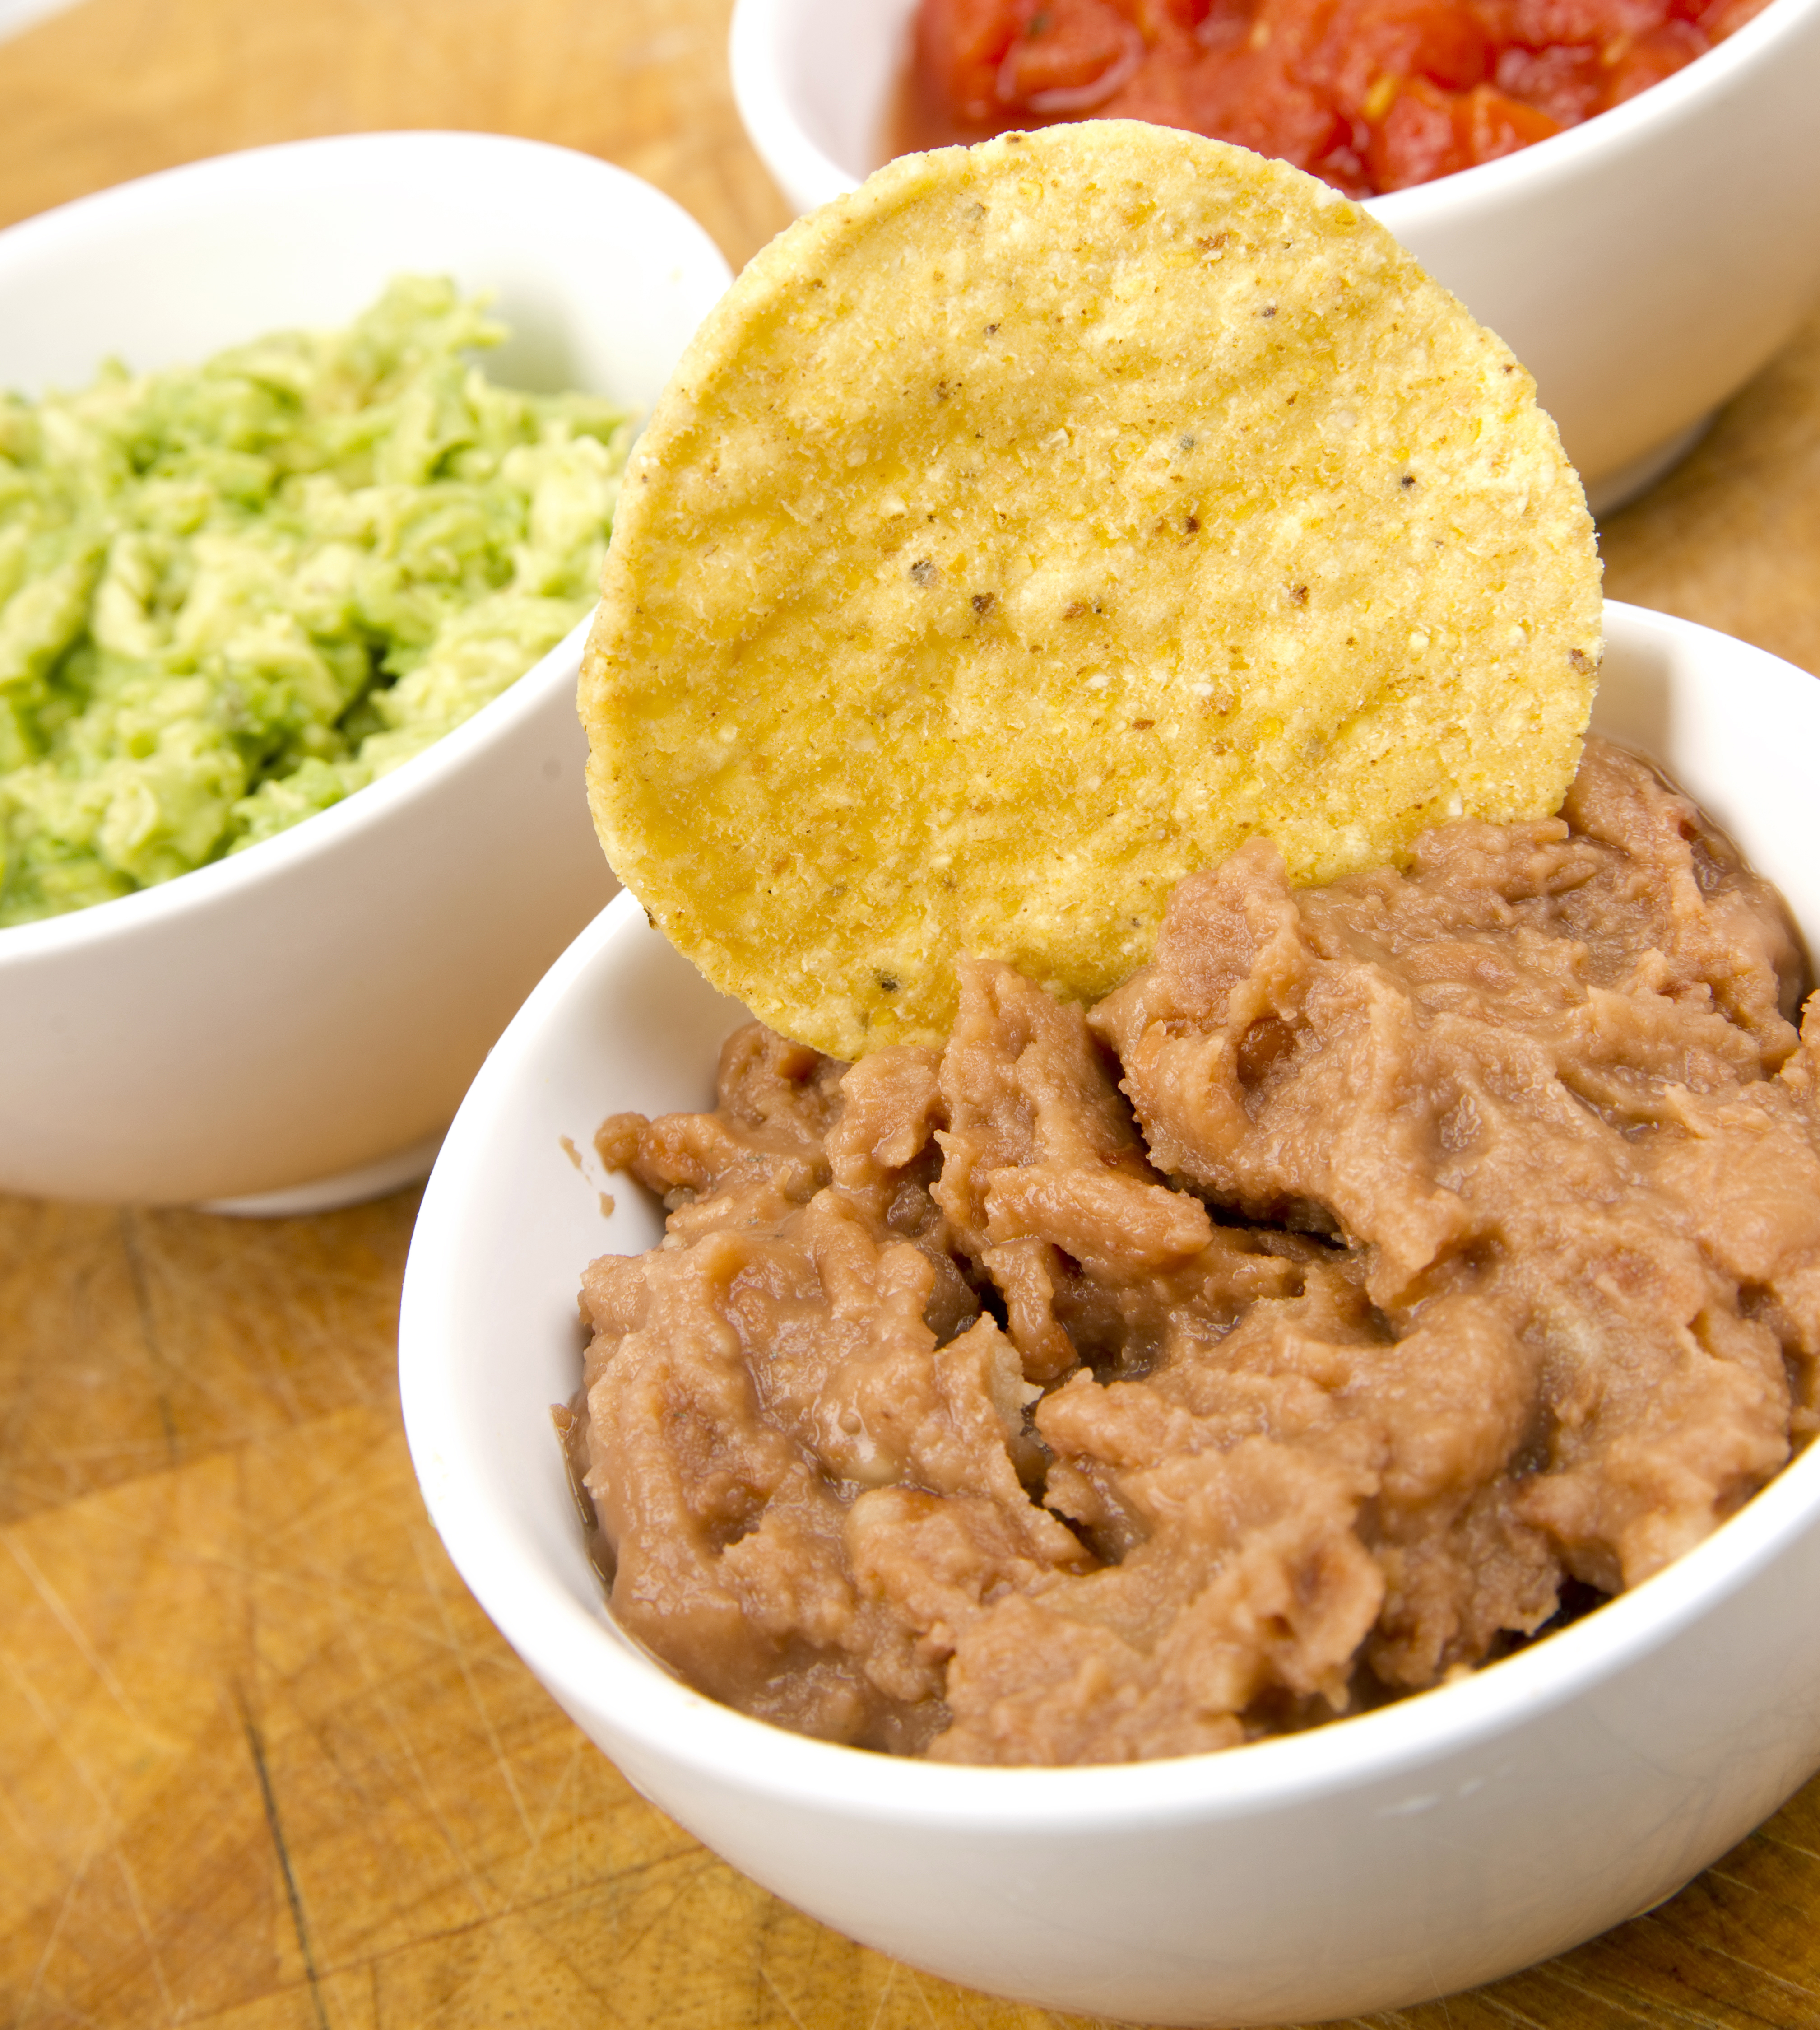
[{"xmin": 400, "ymin": 605, "xmax": 1820, "ymax": 2024}]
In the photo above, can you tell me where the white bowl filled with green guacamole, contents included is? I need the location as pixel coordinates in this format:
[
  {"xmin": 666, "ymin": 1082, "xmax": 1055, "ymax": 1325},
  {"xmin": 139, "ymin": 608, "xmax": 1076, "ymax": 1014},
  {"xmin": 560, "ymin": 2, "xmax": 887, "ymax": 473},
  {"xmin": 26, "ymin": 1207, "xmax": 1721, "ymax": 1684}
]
[{"xmin": 0, "ymin": 134, "xmax": 729, "ymax": 1210}]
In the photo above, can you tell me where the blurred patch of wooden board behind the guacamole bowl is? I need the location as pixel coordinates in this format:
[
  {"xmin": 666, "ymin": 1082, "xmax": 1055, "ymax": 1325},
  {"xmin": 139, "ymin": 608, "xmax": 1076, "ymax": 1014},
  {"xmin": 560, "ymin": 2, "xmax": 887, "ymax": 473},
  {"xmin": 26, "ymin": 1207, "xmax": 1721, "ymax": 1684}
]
[{"xmin": 0, "ymin": 0, "xmax": 789, "ymax": 266}]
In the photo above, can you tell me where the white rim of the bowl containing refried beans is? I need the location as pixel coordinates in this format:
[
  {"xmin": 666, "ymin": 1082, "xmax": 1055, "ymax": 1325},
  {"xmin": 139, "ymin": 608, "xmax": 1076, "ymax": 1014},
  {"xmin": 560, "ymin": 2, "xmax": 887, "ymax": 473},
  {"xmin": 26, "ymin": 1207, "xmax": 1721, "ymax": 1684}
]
[{"xmin": 398, "ymin": 601, "xmax": 1820, "ymax": 1833}]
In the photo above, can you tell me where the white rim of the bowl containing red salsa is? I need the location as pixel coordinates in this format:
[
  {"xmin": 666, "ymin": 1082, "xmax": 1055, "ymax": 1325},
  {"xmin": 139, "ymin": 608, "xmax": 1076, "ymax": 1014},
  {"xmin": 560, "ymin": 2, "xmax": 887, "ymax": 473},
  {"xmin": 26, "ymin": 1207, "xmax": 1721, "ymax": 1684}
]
[{"xmin": 729, "ymin": 0, "xmax": 1820, "ymax": 221}]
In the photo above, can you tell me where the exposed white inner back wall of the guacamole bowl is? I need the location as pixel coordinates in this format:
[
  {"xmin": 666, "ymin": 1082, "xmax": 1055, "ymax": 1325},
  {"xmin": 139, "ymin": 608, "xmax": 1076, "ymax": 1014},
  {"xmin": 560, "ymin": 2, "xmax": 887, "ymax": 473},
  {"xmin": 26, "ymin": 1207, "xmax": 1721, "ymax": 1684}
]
[{"xmin": 0, "ymin": 134, "xmax": 726, "ymax": 408}]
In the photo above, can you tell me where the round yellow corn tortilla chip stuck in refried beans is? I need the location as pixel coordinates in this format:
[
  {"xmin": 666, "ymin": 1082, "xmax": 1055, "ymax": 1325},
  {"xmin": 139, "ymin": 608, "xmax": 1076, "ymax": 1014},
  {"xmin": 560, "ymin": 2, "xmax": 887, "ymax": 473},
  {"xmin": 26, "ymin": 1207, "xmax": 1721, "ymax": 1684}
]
[{"xmin": 580, "ymin": 122, "xmax": 1601, "ymax": 1057}]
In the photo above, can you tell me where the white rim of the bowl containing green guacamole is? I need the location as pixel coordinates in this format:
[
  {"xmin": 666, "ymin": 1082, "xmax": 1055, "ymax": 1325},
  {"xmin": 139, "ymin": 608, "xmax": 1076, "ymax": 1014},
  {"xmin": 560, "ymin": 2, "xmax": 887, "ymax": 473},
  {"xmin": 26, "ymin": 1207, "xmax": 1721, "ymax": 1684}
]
[{"xmin": 0, "ymin": 128, "xmax": 724, "ymax": 974}]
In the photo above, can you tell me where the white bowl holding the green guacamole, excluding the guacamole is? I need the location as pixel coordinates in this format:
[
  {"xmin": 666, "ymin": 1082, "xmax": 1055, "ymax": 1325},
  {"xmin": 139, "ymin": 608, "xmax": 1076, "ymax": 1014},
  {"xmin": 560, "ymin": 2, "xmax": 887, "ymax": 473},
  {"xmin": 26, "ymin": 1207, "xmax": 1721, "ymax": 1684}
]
[{"xmin": 0, "ymin": 134, "xmax": 729, "ymax": 1210}]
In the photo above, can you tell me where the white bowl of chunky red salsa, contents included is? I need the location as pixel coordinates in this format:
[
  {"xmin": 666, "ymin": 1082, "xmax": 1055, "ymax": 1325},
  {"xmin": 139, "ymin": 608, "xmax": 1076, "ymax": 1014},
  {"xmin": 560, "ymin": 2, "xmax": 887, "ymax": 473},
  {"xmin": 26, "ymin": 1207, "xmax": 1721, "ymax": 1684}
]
[{"xmin": 730, "ymin": 0, "xmax": 1820, "ymax": 512}]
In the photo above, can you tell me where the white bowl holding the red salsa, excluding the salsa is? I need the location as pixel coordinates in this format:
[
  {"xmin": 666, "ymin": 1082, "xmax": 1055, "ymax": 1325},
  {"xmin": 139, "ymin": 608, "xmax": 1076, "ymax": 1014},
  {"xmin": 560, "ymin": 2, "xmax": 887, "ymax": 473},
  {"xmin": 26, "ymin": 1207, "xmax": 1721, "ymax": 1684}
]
[{"xmin": 730, "ymin": 0, "xmax": 1820, "ymax": 513}]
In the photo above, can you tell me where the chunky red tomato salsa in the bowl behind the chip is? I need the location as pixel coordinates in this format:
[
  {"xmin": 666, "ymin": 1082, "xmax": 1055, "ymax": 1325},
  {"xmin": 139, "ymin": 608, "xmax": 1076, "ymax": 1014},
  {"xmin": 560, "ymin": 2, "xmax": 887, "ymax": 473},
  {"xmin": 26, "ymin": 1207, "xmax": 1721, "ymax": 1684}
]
[{"xmin": 893, "ymin": 0, "xmax": 1765, "ymax": 197}]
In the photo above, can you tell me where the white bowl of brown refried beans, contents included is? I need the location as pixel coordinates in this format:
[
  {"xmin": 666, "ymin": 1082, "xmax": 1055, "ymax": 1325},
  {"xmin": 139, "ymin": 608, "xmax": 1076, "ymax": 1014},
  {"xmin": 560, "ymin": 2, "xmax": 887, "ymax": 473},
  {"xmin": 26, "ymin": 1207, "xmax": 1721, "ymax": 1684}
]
[{"xmin": 400, "ymin": 605, "xmax": 1820, "ymax": 2024}]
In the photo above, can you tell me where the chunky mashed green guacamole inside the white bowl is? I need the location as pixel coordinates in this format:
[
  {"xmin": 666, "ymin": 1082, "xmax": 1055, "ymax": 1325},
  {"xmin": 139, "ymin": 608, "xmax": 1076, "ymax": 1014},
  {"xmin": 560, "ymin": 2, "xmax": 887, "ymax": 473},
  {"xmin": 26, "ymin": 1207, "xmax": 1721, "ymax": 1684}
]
[{"xmin": 0, "ymin": 278, "xmax": 631, "ymax": 926}]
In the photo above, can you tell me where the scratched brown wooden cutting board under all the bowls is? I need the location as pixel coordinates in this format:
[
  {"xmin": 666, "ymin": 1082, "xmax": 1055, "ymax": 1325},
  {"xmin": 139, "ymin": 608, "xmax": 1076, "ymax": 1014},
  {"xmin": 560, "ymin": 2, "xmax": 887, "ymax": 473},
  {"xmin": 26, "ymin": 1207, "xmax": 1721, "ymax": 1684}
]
[{"xmin": 0, "ymin": 0, "xmax": 1820, "ymax": 2030}]
